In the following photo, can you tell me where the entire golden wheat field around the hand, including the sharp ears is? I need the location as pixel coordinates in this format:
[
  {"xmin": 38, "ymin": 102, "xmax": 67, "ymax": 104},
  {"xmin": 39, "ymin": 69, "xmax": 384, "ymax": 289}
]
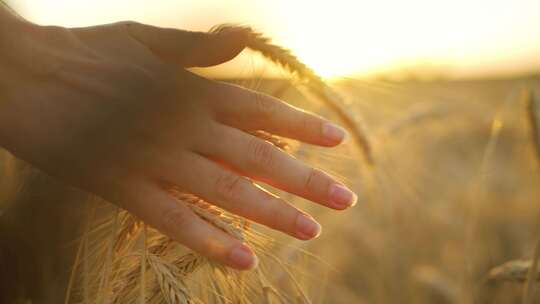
[{"xmin": 0, "ymin": 14, "xmax": 540, "ymax": 304}]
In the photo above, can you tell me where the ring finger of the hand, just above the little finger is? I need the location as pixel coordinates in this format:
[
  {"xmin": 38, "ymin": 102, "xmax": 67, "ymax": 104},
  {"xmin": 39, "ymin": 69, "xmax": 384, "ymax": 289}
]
[{"xmin": 158, "ymin": 154, "xmax": 321, "ymax": 240}]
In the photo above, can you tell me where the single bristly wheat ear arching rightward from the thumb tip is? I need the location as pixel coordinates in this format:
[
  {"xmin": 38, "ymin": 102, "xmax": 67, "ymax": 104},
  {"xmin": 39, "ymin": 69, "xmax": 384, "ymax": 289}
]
[{"xmin": 210, "ymin": 24, "xmax": 374, "ymax": 165}]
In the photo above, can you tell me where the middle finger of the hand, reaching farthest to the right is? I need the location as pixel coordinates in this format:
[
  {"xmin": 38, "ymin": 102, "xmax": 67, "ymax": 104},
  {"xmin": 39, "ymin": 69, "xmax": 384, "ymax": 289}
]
[{"xmin": 207, "ymin": 126, "xmax": 357, "ymax": 210}]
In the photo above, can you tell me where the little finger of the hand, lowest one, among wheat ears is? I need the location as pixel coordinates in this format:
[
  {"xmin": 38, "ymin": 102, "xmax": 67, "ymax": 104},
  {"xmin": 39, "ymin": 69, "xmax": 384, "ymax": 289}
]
[{"xmin": 123, "ymin": 179, "xmax": 257, "ymax": 270}]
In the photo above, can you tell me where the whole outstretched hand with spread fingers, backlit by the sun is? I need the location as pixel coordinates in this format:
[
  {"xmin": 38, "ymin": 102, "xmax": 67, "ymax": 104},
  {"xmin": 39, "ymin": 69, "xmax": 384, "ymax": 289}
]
[{"xmin": 0, "ymin": 8, "xmax": 356, "ymax": 270}]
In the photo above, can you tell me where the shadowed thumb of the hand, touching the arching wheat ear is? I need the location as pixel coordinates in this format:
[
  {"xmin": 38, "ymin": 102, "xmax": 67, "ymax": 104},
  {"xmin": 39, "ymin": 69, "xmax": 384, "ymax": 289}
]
[{"xmin": 122, "ymin": 22, "xmax": 248, "ymax": 67}]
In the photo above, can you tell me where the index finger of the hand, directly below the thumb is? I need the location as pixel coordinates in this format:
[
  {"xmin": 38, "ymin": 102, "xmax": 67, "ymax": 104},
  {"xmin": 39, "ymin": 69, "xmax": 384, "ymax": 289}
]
[{"xmin": 211, "ymin": 84, "xmax": 346, "ymax": 146}]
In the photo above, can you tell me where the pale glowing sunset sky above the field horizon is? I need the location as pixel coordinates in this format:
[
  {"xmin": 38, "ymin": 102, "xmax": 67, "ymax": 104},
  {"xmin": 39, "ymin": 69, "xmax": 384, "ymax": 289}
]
[{"xmin": 11, "ymin": 0, "xmax": 540, "ymax": 77}]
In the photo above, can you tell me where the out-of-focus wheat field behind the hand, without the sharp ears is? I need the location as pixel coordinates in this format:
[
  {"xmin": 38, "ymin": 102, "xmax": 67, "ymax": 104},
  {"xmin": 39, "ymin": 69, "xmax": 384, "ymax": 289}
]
[{"xmin": 0, "ymin": 72, "xmax": 540, "ymax": 304}]
